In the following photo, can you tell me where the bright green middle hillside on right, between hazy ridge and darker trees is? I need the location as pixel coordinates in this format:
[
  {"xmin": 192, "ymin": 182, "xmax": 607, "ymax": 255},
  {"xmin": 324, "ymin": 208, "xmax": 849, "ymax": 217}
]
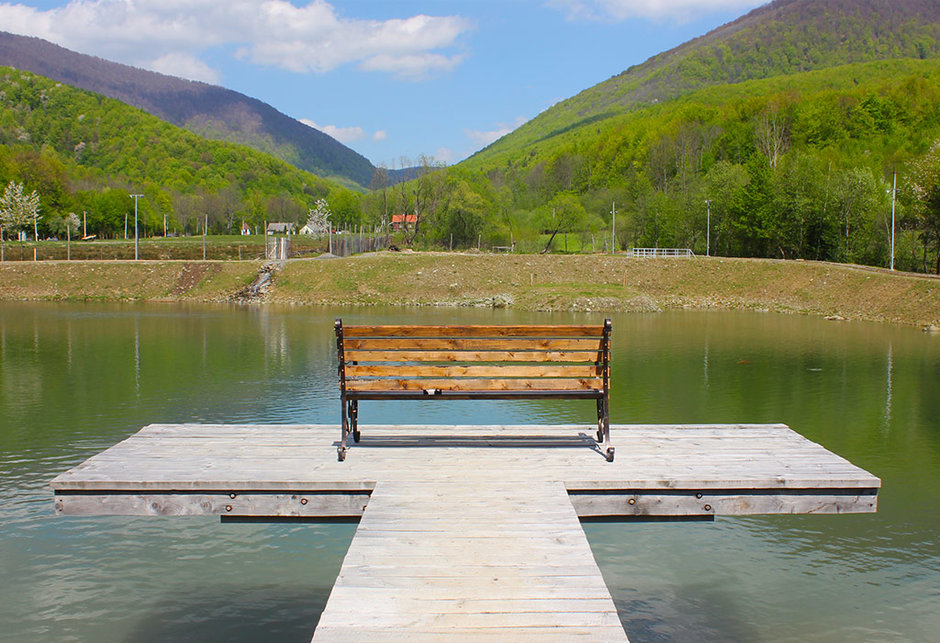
[{"xmin": 462, "ymin": 60, "xmax": 940, "ymax": 175}]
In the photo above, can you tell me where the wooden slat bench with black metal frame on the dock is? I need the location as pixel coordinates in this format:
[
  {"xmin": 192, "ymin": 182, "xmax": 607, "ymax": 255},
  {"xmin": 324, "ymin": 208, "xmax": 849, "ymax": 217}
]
[{"xmin": 335, "ymin": 319, "xmax": 614, "ymax": 462}]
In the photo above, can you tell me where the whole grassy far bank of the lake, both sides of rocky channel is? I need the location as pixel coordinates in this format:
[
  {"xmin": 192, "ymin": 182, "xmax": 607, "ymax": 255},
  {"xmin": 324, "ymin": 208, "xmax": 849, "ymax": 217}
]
[{"xmin": 0, "ymin": 252, "xmax": 940, "ymax": 326}]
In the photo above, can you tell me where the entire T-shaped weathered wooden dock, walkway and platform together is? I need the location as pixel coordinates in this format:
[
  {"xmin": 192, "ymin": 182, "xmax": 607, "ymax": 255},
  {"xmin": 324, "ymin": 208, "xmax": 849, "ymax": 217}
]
[{"xmin": 52, "ymin": 425, "xmax": 881, "ymax": 641}]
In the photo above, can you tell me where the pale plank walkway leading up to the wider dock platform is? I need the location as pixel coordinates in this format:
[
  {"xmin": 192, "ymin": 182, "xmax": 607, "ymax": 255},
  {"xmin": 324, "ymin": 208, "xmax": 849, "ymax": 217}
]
[{"xmin": 313, "ymin": 480, "xmax": 626, "ymax": 641}]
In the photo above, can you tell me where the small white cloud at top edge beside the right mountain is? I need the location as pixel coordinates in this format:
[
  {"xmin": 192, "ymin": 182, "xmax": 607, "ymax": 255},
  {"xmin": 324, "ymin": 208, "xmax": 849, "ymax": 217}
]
[{"xmin": 546, "ymin": 0, "xmax": 769, "ymax": 22}]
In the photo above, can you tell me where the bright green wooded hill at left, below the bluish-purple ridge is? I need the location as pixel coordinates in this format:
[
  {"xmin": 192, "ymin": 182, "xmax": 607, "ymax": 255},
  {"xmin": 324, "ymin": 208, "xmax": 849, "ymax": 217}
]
[{"xmin": 0, "ymin": 67, "xmax": 358, "ymax": 236}]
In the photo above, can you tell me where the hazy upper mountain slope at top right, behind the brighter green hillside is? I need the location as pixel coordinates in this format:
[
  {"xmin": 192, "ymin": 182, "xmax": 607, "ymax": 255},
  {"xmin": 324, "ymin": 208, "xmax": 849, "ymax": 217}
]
[{"xmin": 471, "ymin": 0, "xmax": 940, "ymax": 159}]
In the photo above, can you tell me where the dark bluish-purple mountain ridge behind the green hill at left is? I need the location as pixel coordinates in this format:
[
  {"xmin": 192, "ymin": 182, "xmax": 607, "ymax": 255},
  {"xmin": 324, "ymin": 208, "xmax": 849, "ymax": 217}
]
[{"xmin": 0, "ymin": 32, "xmax": 374, "ymax": 186}]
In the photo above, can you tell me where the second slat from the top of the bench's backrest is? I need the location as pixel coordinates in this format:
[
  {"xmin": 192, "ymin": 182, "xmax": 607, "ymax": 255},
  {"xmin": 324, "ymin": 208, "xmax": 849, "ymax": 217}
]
[{"xmin": 343, "ymin": 337, "xmax": 601, "ymax": 351}]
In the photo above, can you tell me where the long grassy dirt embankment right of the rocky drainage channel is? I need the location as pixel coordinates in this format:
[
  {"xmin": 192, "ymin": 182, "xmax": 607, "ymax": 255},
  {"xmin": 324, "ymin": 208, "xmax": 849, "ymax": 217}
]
[{"xmin": 267, "ymin": 253, "xmax": 940, "ymax": 326}]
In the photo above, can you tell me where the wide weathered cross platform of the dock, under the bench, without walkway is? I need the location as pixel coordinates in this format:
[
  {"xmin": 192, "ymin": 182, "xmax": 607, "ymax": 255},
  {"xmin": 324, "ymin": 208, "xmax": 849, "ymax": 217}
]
[{"xmin": 52, "ymin": 424, "xmax": 880, "ymax": 518}]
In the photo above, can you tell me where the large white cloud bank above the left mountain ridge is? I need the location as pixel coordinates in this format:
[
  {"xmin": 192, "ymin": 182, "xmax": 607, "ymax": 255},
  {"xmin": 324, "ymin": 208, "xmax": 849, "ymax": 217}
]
[{"xmin": 0, "ymin": 0, "xmax": 473, "ymax": 79}]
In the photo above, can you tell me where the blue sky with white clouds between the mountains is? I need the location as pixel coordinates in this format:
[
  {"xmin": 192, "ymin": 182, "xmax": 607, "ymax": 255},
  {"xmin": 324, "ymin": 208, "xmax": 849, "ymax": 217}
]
[{"xmin": 0, "ymin": 0, "xmax": 763, "ymax": 168}]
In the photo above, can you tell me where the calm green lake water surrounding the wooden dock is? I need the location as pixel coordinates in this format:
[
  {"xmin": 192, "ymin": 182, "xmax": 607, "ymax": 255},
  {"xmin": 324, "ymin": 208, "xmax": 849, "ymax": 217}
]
[{"xmin": 0, "ymin": 304, "xmax": 940, "ymax": 642}]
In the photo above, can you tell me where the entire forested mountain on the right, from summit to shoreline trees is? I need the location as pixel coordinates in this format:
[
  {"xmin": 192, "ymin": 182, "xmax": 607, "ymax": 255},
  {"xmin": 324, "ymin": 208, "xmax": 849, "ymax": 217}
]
[{"xmin": 366, "ymin": 0, "xmax": 940, "ymax": 272}]
